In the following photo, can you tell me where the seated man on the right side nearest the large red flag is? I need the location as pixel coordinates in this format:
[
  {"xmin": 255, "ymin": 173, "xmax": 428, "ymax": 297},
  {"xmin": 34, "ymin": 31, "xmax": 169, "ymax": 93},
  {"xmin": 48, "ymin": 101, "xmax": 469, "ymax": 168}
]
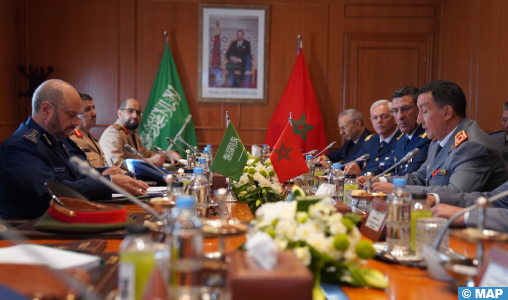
[{"xmin": 319, "ymin": 109, "xmax": 370, "ymax": 163}]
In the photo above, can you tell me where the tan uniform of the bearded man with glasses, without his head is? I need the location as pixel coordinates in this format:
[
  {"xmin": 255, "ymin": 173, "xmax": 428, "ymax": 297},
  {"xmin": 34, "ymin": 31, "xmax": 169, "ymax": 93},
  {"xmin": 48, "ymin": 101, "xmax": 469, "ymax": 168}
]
[{"xmin": 99, "ymin": 119, "xmax": 155, "ymax": 170}]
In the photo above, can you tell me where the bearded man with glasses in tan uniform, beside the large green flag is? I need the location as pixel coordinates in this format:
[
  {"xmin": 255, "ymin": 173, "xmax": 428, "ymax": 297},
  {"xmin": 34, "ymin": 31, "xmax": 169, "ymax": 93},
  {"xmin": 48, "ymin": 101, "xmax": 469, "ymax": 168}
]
[{"xmin": 99, "ymin": 98, "xmax": 181, "ymax": 170}]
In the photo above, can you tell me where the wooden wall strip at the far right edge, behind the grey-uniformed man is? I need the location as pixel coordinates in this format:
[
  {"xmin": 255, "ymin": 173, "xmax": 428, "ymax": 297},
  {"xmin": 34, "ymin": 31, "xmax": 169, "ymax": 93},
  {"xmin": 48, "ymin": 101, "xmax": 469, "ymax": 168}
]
[{"xmin": 473, "ymin": 0, "xmax": 508, "ymax": 132}]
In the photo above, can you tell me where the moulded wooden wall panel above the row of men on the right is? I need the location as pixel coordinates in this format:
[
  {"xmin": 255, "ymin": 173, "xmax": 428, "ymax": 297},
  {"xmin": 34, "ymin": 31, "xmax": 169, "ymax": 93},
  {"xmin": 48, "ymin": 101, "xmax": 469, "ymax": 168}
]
[{"xmin": 344, "ymin": 34, "xmax": 432, "ymax": 130}]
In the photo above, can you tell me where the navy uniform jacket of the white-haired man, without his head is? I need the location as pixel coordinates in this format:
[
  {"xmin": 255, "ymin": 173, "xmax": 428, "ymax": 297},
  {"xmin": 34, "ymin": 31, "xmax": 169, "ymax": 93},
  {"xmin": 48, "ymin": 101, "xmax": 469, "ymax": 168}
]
[{"xmin": 353, "ymin": 129, "xmax": 402, "ymax": 174}]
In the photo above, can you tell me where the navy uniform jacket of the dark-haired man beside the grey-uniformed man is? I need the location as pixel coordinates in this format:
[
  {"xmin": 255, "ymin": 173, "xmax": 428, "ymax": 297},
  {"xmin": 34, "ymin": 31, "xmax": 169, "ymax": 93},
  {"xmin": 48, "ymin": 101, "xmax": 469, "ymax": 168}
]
[{"xmin": 374, "ymin": 125, "xmax": 431, "ymax": 176}]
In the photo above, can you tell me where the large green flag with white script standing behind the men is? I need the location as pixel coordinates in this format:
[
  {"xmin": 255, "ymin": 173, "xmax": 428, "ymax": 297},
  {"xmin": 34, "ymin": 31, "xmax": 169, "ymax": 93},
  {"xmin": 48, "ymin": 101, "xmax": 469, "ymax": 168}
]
[{"xmin": 139, "ymin": 45, "xmax": 198, "ymax": 157}]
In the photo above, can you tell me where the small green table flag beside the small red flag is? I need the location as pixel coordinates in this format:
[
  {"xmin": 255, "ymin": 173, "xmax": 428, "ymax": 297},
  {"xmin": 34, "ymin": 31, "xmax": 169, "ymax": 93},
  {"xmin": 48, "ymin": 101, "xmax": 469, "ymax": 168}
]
[{"xmin": 210, "ymin": 122, "xmax": 249, "ymax": 181}]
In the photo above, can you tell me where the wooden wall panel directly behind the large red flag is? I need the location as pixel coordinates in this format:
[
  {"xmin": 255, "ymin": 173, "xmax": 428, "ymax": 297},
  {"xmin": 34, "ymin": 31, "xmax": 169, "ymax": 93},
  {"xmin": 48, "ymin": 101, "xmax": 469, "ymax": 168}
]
[{"xmin": 237, "ymin": 3, "xmax": 329, "ymax": 146}]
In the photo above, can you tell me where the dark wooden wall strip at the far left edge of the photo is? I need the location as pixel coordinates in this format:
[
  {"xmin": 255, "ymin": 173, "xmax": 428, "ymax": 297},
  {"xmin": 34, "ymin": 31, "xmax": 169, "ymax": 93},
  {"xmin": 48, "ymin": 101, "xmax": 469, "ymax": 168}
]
[{"xmin": 0, "ymin": 0, "xmax": 24, "ymax": 144}]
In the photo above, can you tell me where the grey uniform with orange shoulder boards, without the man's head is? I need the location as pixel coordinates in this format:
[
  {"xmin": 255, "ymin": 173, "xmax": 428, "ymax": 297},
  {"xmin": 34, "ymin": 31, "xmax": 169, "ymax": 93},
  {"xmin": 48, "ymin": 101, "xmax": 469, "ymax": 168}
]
[{"xmin": 386, "ymin": 118, "xmax": 508, "ymax": 193}]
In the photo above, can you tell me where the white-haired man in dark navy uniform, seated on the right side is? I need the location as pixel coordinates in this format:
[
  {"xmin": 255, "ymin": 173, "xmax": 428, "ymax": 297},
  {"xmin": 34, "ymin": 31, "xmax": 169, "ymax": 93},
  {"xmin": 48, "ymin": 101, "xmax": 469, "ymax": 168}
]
[{"xmin": 344, "ymin": 100, "xmax": 402, "ymax": 175}]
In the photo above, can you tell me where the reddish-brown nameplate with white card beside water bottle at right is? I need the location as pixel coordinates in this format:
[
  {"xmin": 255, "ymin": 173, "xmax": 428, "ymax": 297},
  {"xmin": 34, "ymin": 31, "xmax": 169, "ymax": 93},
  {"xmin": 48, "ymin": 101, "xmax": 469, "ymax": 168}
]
[{"xmin": 360, "ymin": 198, "xmax": 388, "ymax": 242}]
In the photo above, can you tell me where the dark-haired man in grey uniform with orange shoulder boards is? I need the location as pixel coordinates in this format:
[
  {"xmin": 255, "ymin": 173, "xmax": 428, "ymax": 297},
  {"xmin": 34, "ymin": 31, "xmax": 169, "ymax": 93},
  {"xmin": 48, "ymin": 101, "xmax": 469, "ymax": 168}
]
[{"xmin": 358, "ymin": 80, "xmax": 508, "ymax": 192}]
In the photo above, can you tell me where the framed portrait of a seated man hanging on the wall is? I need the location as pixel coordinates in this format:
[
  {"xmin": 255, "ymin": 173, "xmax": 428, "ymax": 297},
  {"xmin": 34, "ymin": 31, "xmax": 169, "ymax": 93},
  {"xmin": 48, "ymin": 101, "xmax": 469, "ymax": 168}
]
[{"xmin": 198, "ymin": 4, "xmax": 270, "ymax": 103}]
